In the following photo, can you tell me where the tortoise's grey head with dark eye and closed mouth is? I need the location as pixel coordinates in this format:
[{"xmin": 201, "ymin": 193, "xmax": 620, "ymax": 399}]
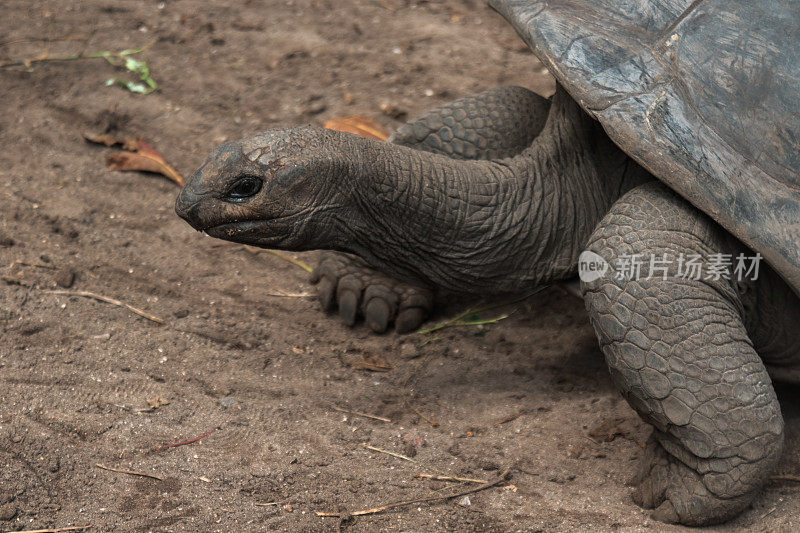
[{"xmin": 175, "ymin": 127, "xmax": 344, "ymax": 250}]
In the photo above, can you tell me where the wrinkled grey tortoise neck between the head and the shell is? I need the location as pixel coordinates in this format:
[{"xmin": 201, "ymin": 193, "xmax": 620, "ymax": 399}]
[{"xmin": 324, "ymin": 89, "xmax": 644, "ymax": 294}]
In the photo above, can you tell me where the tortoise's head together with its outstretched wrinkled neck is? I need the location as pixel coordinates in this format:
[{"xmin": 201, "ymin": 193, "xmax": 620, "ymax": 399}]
[{"xmin": 176, "ymin": 91, "xmax": 646, "ymax": 295}]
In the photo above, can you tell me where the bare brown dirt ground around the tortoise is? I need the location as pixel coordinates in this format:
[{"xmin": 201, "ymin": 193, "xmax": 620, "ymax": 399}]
[{"xmin": 0, "ymin": 0, "xmax": 800, "ymax": 531}]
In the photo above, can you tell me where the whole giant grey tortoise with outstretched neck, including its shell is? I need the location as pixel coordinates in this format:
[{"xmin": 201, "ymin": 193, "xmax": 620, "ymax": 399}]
[{"xmin": 176, "ymin": 0, "xmax": 800, "ymax": 525}]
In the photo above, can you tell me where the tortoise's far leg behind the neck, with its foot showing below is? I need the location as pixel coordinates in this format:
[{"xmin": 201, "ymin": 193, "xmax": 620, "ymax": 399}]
[{"xmin": 312, "ymin": 86, "xmax": 550, "ymax": 333}]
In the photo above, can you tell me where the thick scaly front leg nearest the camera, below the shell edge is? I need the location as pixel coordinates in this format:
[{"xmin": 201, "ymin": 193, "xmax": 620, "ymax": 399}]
[{"xmin": 582, "ymin": 183, "xmax": 783, "ymax": 525}]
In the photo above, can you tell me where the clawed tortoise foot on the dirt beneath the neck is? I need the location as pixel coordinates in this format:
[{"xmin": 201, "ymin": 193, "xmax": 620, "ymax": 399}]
[{"xmin": 311, "ymin": 252, "xmax": 433, "ymax": 333}]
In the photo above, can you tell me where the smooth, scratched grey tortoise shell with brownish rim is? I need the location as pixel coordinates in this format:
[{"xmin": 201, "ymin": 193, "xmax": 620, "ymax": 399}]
[{"xmin": 489, "ymin": 0, "xmax": 800, "ymax": 294}]
